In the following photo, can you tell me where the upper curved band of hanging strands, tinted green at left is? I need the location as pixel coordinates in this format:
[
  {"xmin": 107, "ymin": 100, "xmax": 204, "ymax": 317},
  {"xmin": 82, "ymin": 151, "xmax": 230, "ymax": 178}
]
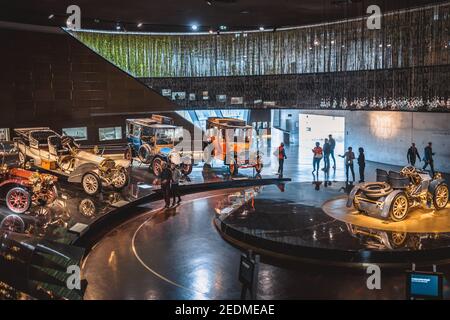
[{"xmin": 74, "ymin": 3, "xmax": 450, "ymax": 77}]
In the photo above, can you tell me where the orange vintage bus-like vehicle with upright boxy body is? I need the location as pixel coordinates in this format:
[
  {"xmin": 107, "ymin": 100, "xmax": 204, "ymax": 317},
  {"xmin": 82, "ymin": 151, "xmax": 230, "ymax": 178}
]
[{"xmin": 206, "ymin": 117, "xmax": 263, "ymax": 175}]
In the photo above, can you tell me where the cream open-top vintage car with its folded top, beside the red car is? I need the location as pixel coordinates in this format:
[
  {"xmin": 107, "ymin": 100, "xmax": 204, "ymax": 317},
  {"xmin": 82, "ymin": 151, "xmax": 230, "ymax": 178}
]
[{"xmin": 14, "ymin": 128, "xmax": 130, "ymax": 196}]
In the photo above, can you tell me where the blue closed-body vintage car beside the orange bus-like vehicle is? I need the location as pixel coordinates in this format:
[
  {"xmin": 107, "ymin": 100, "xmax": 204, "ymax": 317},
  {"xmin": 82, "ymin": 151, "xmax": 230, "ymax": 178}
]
[{"xmin": 127, "ymin": 115, "xmax": 192, "ymax": 176}]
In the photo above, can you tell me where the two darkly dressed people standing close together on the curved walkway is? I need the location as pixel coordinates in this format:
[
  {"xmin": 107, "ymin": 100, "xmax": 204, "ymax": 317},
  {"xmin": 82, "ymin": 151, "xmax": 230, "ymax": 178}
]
[{"xmin": 158, "ymin": 163, "xmax": 182, "ymax": 209}]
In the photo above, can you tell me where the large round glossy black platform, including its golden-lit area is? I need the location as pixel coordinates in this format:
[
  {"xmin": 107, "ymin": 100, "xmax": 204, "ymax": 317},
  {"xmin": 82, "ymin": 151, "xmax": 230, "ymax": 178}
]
[{"xmin": 215, "ymin": 182, "xmax": 450, "ymax": 268}]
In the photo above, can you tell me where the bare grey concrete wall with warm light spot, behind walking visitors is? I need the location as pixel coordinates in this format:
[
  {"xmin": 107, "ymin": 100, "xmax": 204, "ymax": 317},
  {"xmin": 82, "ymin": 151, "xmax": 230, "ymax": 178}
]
[{"xmin": 300, "ymin": 110, "xmax": 450, "ymax": 173}]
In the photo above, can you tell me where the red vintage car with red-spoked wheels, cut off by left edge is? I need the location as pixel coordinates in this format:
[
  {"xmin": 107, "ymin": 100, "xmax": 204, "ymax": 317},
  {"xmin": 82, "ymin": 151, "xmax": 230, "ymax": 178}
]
[{"xmin": 0, "ymin": 164, "xmax": 58, "ymax": 214}]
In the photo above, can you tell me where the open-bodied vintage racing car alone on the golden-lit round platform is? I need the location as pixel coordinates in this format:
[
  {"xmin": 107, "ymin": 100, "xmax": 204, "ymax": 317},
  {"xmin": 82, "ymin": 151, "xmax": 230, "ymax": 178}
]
[{"xmin": 347, "ymin": 166, "xmax": 449, "ymax": 221}]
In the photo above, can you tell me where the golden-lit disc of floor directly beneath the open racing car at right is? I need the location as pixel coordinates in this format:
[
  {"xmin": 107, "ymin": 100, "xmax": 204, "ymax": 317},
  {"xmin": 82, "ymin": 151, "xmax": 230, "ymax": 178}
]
[{"xmin": 322, "ymin": 195, "xmax": 450, "ymax": 233}]
